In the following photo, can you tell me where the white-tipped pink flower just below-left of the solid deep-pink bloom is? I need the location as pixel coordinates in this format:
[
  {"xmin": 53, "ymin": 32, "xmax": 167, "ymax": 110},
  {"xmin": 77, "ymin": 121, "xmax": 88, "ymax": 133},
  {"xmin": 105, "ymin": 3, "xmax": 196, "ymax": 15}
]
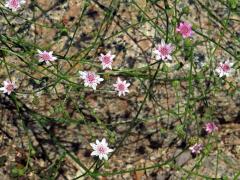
[{"xmin": 154, "ymin": 40, "xmax": 173, "ymax": 61}]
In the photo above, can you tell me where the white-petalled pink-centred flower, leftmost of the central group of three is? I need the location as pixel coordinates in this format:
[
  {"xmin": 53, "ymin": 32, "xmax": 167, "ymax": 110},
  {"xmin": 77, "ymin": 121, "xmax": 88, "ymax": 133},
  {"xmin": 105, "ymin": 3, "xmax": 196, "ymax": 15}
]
[{"xmin": 79, "ymin": 71, "xmax": 104, "ymax": 90}]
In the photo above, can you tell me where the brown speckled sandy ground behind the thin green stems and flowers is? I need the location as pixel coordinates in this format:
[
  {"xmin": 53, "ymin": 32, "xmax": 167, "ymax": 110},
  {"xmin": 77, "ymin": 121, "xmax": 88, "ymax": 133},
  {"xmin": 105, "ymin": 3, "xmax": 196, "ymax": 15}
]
[{"xmin": 0, "ymin": 0, "xmax": 240, "ymax": 179}]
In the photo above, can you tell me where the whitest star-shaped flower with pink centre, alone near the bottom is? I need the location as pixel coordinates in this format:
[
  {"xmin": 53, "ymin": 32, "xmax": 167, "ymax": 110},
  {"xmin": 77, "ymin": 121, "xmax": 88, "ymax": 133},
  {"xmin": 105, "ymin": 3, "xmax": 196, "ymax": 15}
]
[{"xmin": 90, "ymin": 138, "xmax": 113, "ymax": 160}]
